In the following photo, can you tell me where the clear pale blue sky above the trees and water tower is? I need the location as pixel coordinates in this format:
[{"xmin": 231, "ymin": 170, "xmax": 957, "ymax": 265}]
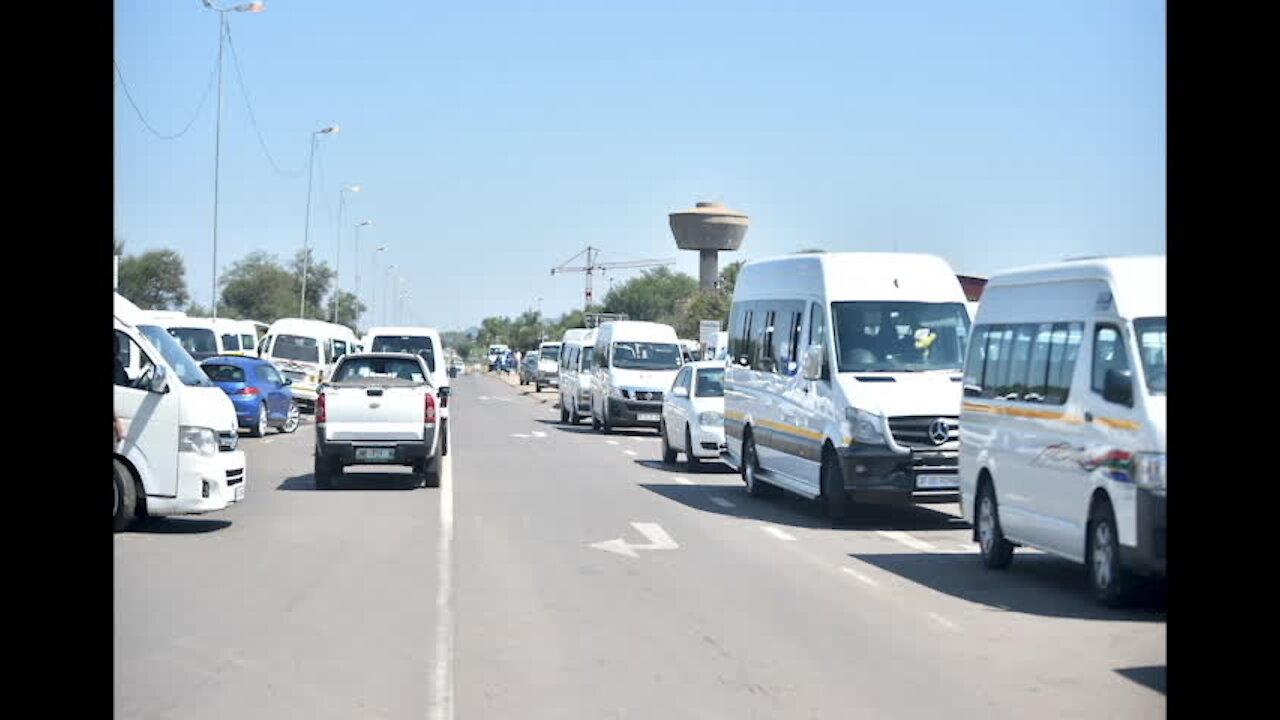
[{"xmin": 115, "ymin": 0, "xmax": 1166, "ymax": 329}]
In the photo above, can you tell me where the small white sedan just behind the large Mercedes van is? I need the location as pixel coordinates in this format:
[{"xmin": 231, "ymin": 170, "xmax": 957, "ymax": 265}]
[{"xmin": 658, "ymin": 360, "xmax": 724, "ymax": 473}]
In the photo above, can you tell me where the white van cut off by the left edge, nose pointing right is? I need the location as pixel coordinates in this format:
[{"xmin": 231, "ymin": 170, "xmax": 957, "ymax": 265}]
[{"xmin": 113, "ymin": 288, "xmax": 246, "ymax": 530}]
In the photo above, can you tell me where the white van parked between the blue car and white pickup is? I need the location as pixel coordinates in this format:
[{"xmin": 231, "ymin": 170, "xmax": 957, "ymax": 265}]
[{"xmin": 259, "ymin": 318, "xmax": 360, "ymax": 409}]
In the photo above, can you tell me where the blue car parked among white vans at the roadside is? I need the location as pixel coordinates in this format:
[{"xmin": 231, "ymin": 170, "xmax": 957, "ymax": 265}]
[{"xmin": 200, "ymin": 355, "xmax": 298, "ymax": 437}]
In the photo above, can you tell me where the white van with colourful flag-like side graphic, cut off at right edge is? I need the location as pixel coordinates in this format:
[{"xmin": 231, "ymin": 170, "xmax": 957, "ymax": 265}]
[{"xmin": 960, "ymin": 256, "xmax": 1169, "ymax": 603}]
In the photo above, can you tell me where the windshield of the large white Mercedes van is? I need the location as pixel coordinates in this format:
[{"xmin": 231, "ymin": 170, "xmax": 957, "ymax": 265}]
[{"xmin": 831, "ymin": 302, "xmax": 969, "ymax": 373}]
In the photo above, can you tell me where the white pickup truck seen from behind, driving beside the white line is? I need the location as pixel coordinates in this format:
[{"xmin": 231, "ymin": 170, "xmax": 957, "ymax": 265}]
[{"xmin": 315, "ymin": 352, "xmax": 442, "ymax": 488}]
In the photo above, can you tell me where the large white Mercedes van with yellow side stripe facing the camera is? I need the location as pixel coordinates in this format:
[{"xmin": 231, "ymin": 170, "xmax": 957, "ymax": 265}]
[{"xmin": 724, "ymin": 252, "xmax": 969, "ymax": 520}]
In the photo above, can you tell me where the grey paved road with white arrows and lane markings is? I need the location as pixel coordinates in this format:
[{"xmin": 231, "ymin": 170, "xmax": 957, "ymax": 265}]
[{"xmin": 115, "ymin": 375, "xmax": 1166, "ymax": 720}]
